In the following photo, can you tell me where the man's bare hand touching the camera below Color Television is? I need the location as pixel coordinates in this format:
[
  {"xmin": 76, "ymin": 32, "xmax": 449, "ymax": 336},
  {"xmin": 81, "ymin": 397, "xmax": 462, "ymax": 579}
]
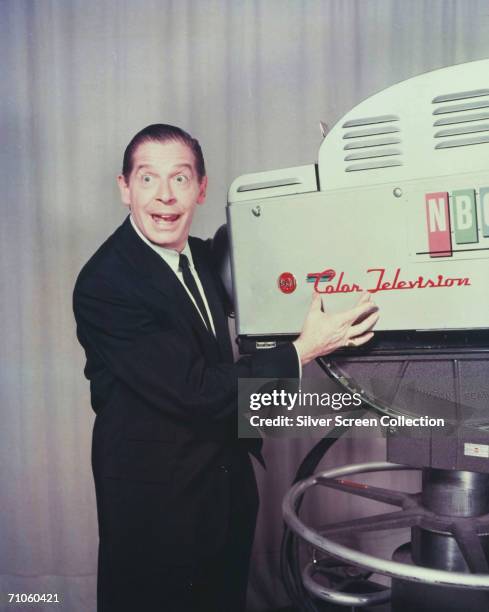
[{"xmin": 294, "ymin": 292, "xmax": 379, "ymax": 365}]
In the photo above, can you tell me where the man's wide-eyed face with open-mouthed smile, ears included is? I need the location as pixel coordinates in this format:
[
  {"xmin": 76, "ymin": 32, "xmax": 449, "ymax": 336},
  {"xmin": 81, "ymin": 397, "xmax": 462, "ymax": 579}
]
[{"xmin": 117, "ymin": 140, "xmax": 207, "ymax": 252}]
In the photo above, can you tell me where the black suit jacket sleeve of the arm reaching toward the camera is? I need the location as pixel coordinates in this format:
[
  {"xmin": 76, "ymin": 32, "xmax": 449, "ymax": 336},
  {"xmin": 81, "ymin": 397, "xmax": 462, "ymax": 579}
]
[{"xmin": 74, "ymin": 276, "xmax": 299, "ymax": 421}]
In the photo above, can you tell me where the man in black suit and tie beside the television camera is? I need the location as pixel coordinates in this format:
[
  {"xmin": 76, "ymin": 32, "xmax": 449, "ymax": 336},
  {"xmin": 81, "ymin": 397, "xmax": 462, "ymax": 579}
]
[{"xmin": 74, "ymin": 124, "xmax": 377, "ymax": 612}]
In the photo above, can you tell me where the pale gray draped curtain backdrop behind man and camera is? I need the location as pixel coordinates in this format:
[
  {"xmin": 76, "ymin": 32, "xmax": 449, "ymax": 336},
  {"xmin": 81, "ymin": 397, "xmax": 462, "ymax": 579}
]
[{"xmin": 0, "ymin": 0, "xmax": 489, "ymax": 612}]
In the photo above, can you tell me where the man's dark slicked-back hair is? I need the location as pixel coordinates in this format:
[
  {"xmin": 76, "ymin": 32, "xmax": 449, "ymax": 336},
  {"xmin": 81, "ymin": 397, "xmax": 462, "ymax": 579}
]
[{"xmin": 122, "ymin": 123, "xmax": 205, "ymax": 183}]
